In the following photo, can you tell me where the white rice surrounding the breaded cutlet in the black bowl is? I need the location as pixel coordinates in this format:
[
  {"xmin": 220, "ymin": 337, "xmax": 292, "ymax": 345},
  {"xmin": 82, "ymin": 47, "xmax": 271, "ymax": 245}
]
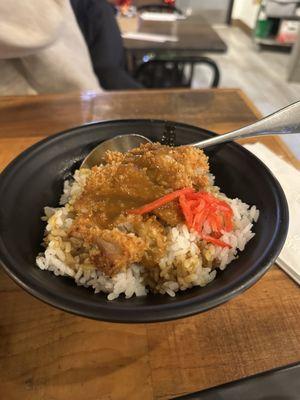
[{"xmin": 36, "ymin": 170, "xmax": 259, "ymax": 300}]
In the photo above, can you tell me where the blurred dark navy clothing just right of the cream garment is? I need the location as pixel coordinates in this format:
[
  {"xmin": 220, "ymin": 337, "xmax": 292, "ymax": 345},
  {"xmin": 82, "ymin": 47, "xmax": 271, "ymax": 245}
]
[{"xmin": 71, "ymin": 0, "xmax": 142, "ymax": 90}]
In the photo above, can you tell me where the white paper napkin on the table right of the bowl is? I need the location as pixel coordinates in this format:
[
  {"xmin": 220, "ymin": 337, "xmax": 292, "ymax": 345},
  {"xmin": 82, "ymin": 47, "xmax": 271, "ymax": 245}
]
[{"xmin": 244, "ymin": 143, "xmax": 300, "ymax": 284}]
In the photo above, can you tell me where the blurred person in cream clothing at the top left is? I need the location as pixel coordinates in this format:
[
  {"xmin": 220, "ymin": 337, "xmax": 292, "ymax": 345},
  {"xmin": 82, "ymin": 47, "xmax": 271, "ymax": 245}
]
[{"xmin": 0, "ymin": 0, "xmax": 101, "ymax": 95}]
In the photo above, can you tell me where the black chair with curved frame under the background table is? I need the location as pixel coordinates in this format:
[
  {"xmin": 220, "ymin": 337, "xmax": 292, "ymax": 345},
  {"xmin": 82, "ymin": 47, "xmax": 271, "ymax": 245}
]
[{"xmin": 134, "ymin": 56, "xmax": 220, "ymax": 89}]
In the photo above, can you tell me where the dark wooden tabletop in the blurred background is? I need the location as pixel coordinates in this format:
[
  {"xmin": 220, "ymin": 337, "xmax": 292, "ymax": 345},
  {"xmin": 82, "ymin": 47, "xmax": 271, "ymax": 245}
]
[{"xmin": 118, "ymin": 15, "xmax": 227, "ymax": 54}]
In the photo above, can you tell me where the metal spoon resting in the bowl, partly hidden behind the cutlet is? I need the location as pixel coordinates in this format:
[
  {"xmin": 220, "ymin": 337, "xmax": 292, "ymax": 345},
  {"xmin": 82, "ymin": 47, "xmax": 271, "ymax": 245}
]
[{"xmin": 81, "ymin": 101, "xmax": 300, "ymax": 168}]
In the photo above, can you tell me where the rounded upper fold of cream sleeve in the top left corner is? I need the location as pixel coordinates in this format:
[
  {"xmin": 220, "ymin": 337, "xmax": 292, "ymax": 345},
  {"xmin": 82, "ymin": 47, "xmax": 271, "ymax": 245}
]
[{"xmin": 0, "ymin": 0, "xmax": 68, "ymax": 59}]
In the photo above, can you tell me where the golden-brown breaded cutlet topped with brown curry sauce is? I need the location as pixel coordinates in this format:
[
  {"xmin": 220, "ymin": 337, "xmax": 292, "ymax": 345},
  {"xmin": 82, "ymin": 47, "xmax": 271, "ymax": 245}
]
[{"xmin": 69, "ymin": 143, "xmax": 209, "ymax": 276}]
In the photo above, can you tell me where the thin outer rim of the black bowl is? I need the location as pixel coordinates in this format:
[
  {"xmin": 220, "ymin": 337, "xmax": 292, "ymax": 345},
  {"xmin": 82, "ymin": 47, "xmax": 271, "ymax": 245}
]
[{"xmin": 0, "ymin": 118, "xmax": 289, "ymax": 323}]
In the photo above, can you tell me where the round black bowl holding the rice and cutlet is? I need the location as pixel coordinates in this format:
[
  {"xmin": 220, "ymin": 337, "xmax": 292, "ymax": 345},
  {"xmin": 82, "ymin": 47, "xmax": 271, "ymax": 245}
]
[{"xmin": 0, "ymin": 120, "xmax": 288, "ymax": 322}]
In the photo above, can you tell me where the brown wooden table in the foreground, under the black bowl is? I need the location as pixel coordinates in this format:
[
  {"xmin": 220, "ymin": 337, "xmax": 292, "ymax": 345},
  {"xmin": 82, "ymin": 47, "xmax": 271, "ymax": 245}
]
[{"xmin": 0, "ymin": 89, "xmax": 300, "ymax": 400}]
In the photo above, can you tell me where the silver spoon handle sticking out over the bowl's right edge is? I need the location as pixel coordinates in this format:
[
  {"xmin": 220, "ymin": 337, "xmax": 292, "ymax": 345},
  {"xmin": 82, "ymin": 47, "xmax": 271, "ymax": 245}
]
[{"xmin": 191, "ymin": 101, "xmax": 300, "ymax": 149}]
